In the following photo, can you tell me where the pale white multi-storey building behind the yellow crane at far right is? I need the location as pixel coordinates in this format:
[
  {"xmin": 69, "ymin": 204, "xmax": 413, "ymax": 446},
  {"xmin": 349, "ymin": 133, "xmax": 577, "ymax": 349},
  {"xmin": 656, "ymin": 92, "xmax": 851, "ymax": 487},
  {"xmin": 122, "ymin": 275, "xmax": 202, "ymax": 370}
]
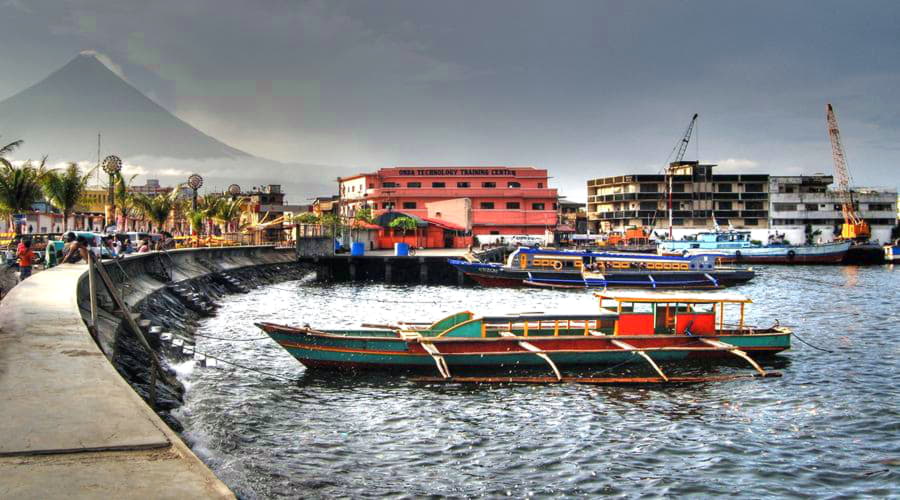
[{"xmin": 769, "ymin": 174, "xmax": 898, "ymax": 244}]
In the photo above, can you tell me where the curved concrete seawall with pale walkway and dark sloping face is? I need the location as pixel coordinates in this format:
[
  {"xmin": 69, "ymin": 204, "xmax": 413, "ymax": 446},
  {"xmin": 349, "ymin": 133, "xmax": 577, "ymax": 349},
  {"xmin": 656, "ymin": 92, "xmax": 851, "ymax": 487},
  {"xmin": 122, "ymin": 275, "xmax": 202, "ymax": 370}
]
[{"xmin": 0, "ymin": 247, "xmax": 305, "ymax": 498}]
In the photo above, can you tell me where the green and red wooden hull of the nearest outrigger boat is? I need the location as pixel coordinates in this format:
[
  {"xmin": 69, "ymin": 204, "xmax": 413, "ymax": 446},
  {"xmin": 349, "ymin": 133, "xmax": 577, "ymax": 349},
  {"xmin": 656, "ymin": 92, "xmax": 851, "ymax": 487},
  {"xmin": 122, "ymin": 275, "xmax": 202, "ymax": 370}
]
[{"xmin": 257, "ymin": 323, "xmax": 790, "ymax": 370}]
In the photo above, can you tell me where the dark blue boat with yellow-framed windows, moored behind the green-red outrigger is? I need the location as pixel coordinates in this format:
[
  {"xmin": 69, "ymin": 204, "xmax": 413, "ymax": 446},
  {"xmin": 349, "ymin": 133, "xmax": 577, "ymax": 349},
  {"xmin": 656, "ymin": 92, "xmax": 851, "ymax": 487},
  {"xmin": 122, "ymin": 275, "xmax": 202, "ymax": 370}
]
[{"xmin": 448, "ymin": 247, "xmax": 755, "ymax": 289}]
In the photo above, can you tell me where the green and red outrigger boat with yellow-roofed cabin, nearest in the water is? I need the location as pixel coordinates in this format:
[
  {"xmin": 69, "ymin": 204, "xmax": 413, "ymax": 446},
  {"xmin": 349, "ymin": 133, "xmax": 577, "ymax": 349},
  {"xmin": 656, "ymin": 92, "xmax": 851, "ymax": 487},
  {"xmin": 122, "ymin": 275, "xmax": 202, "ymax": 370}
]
[{"xmin": 257, "ymin": 291, "xmax": 791, "ymax": 383}]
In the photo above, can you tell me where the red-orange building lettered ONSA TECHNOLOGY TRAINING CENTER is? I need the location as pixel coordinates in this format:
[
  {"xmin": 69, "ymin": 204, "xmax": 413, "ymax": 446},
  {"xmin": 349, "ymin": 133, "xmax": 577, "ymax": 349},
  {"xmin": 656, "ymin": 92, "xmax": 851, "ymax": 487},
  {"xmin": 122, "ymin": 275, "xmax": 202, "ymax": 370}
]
[{"xmin": 338, "ymin": 167, "xmax": 558, "ymax": 246}]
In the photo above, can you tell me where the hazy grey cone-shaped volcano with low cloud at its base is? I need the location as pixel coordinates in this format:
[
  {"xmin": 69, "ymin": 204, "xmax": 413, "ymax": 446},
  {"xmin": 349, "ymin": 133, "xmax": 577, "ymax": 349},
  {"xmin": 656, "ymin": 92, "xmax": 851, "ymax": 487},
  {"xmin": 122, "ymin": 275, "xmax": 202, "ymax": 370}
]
[{"xmin": 0, "ymin": 51, "xmax": 349, "ymax": 198}]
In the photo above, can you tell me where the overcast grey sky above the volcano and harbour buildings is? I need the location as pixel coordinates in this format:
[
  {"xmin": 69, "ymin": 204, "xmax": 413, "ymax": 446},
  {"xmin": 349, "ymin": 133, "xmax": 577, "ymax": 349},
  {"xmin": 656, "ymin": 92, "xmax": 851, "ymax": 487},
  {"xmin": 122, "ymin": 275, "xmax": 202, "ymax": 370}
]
[{"xmin": 0, "ymin": 0, "xmax": 900, "ymax": 201}]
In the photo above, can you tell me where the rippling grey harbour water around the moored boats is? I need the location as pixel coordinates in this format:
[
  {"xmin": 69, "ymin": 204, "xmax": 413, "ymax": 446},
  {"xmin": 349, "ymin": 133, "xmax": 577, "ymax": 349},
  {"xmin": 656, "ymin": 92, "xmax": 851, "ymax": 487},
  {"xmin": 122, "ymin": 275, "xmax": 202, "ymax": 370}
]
[{"xmin": 172, "ymin": 266, "xmax": 900, "ymax": 498}]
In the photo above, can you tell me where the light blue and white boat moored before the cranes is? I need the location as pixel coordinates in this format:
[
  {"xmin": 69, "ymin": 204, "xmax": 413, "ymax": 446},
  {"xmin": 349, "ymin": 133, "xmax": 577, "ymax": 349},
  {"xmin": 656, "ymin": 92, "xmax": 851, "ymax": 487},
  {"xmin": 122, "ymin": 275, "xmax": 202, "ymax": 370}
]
[{"xmin": 657, "ymin": 230, "xmax": 851, "ymax": 264}]
